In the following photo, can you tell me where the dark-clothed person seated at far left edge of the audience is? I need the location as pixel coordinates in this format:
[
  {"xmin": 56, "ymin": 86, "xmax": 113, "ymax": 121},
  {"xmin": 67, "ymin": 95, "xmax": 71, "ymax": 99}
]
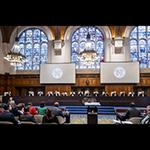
[{"xmin": 0, "ymin": 104, "xmax": 19, "ymax": 125}]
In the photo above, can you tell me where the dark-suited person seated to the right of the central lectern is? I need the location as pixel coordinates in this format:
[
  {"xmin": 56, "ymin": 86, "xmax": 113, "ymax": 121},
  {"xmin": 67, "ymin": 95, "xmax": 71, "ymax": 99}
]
[{"xmin": 116, "ymin": 102, "xmax": 141, "ymax": 121}]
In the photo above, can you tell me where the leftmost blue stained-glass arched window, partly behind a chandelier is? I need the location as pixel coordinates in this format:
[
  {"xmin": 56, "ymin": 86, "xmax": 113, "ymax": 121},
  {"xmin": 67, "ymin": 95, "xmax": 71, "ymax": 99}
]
[{"xmin": 16, "ymin": 28, "xmax": 48, "ymax": 70}]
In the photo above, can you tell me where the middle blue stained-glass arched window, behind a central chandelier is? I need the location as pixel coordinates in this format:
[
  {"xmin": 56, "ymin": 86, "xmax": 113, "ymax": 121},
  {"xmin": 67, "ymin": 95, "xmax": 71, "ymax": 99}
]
[{"xmin": 71, "ymin": 26, "xmax": 104, "ymax": 69}]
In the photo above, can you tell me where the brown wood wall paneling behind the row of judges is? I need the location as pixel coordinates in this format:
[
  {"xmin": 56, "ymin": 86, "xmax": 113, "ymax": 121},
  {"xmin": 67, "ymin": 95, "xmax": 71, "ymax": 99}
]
[{"xmin": 0, "ymin": 73, "xmax": 150, "ymax": 96}]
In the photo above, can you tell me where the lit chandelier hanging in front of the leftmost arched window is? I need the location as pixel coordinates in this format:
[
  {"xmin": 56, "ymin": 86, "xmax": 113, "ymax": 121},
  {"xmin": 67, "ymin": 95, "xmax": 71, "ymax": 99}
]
[{"xmin": 4, "ymin": 29, "xmax": 26, "ymax": 66}]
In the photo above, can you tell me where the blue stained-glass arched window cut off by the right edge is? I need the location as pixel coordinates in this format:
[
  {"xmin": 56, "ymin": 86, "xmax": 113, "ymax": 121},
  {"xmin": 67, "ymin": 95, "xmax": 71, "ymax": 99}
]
[{"xmin": 130, "ymin": 26, "xmax": 150, "ymax": 68}]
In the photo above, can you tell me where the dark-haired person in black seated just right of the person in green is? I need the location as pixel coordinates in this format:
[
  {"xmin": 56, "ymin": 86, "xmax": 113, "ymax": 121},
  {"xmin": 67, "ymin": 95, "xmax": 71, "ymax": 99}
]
[{"xmin": 42, "ymin": 108, "xmax": 59, "ymax": 124}]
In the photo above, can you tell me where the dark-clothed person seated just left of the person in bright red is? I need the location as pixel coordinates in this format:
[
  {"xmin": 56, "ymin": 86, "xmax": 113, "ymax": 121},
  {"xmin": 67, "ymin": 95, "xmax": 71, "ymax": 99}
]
[{"xmin": 19, "ymin": 107, "xmax": 36, "ymax": 123}]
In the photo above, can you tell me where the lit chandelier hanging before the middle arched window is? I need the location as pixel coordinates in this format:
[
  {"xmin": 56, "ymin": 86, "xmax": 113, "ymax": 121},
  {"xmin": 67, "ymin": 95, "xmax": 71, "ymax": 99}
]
[{"xmin": 79, "ymin": 32, "xmax": 97, "ymax": 65}]
